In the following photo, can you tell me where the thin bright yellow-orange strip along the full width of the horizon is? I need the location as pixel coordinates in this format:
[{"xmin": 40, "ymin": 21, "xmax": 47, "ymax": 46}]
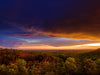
[{"xmin": 1, "ymin": 43, "xmax": 100, "ymax": 50}]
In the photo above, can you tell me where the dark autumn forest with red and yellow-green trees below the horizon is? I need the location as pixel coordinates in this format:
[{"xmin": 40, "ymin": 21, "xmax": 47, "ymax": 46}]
[{"xmin": 0, "ymin": 49, "xmax": 100, "ymax": 75}]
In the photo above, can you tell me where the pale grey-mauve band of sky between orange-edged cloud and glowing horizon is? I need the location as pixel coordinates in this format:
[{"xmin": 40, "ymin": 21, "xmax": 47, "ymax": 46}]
[{"xmin": 21, "ymin": 38, "xmax": 100, "ymax": 47}]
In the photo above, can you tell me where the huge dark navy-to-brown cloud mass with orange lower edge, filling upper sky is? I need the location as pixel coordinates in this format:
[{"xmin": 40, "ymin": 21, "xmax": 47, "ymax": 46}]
[{"xmin": 0, "ymin": 0, "xmax": 100, "ymax": 40}]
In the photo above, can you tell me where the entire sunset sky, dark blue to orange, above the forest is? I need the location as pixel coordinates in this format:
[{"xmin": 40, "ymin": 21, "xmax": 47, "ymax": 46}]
[{"xmin": 0, "ymin": 0, "xmax": 100, "ymax": 50}]
